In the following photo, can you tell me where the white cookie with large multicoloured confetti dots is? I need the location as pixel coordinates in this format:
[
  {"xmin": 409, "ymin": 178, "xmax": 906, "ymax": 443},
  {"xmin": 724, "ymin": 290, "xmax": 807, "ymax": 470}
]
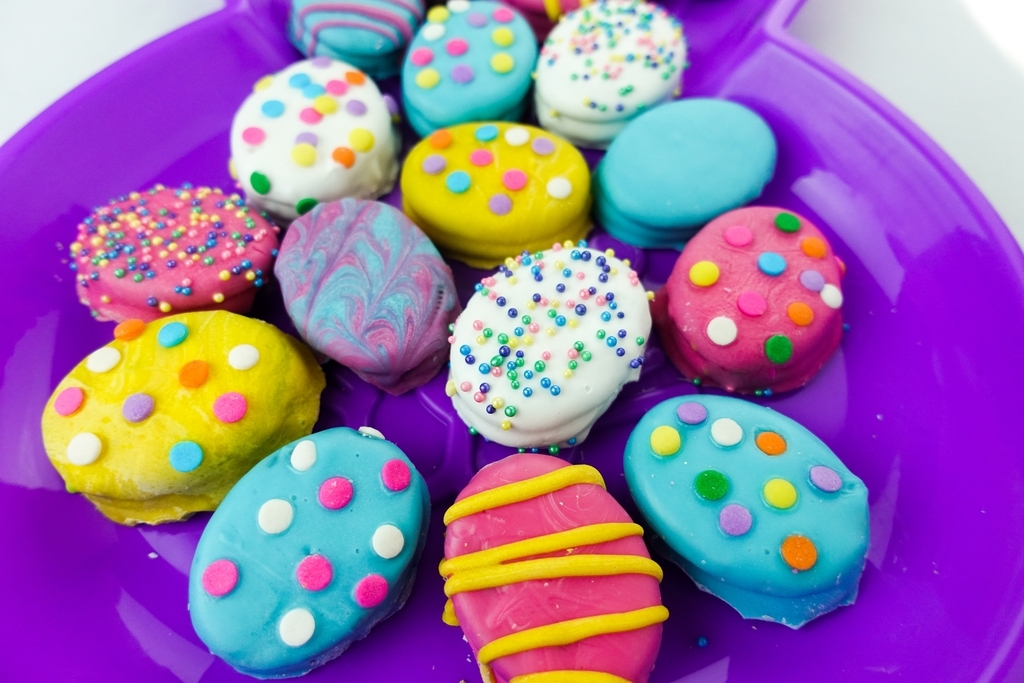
[{"xmin": 231, "ymin": 57, "xmax": 399, "ymax": 220}]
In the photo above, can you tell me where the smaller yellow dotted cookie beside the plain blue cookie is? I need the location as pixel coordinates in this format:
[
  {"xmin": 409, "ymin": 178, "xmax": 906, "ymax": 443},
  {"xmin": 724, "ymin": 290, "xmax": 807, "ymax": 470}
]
[{"xmin": 401, "ymin": 122, "xmax": 591, "ymax": 268}]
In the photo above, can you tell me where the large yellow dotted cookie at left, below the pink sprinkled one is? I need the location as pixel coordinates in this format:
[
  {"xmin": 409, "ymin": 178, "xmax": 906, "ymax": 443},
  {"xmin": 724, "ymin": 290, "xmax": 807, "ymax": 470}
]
[{"xmin": 43, "ymin": 311, "xmax": 325, "ymax": 524}]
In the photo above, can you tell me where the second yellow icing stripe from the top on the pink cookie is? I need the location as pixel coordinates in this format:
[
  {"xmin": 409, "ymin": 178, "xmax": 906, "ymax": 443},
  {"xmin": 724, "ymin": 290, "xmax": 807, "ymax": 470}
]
[{"xmin": 438, "ymin": 522, "xmax": 643, "ymax": 579}]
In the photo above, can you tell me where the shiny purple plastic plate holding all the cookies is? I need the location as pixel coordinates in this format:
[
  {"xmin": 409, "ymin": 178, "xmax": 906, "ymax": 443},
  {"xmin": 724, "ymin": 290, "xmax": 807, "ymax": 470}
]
[{"xmin": 0, "ymin": 0, "xmax": 1024, "ymax": 683}]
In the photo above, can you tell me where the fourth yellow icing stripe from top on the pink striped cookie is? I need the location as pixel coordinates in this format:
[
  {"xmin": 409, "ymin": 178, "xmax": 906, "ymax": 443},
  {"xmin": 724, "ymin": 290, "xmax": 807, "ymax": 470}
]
[{"xmin": 476, "ymin": 605, "xmax": 669, "ymax": 665}]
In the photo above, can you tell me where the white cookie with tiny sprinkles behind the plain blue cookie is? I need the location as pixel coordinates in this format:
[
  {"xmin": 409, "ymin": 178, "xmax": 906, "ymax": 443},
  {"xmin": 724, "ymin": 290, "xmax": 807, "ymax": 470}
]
[{"xmin": 535, "ymin": 0, "xmax": 686, "ymax": 148}]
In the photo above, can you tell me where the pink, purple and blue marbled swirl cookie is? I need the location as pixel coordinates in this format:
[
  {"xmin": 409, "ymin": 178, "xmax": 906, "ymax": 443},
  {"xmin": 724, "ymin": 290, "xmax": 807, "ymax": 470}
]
[{"xmin": 274, "ymin": 199, "xmax": 461, "ymax": 394}]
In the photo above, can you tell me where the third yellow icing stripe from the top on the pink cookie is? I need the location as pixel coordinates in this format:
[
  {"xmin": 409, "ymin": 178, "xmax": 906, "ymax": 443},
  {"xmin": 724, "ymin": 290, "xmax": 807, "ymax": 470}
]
[{"xmin": 444, "ymin": 555, "xmax": 663, "ymax": 597}]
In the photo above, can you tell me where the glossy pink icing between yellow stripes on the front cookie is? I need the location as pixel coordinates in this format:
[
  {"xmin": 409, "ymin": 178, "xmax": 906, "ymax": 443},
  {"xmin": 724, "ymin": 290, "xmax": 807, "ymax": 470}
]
[{"xmin": 444, "ymin": 454, "xmax": 662, "ymax": 683}]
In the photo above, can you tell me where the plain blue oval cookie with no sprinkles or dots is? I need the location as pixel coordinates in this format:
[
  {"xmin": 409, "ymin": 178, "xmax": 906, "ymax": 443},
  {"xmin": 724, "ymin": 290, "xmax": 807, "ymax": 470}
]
[{"xmin": 594, "ymin": 98, "xmax": 777, "ymax": 249}]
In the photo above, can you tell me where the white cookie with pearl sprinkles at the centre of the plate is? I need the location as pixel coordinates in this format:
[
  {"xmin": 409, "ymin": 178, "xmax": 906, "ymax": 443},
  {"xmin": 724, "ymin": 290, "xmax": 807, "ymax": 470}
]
[{"xmin": 447, "ymin": 242, "xmax": 650, "ymax": 447}]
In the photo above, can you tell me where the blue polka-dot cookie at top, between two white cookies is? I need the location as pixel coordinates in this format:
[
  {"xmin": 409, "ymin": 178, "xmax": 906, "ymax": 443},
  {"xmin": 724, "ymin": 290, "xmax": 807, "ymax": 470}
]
[{"xmin": 401, "ymin": 0, "xmax": 538, "ymax": 135}]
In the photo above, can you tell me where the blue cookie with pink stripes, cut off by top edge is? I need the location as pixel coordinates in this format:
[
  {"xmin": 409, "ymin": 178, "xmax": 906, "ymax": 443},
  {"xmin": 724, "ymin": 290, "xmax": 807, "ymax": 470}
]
[{"xmin": 288, "ymin": 0, "xmax": 423, "ymax": 79}]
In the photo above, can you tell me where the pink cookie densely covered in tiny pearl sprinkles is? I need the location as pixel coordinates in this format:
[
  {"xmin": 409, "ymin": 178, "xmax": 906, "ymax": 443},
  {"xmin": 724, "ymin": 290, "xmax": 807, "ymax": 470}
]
[{"xmin": 71, "ymin": 183, "xmax": 278, "ymax": 322}]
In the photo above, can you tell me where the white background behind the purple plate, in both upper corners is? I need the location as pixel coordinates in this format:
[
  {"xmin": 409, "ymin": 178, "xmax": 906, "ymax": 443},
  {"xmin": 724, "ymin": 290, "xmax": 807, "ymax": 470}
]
[{"xmin": 0, "ymin": 0, "xmax": 1024, "ymax": 244}]
